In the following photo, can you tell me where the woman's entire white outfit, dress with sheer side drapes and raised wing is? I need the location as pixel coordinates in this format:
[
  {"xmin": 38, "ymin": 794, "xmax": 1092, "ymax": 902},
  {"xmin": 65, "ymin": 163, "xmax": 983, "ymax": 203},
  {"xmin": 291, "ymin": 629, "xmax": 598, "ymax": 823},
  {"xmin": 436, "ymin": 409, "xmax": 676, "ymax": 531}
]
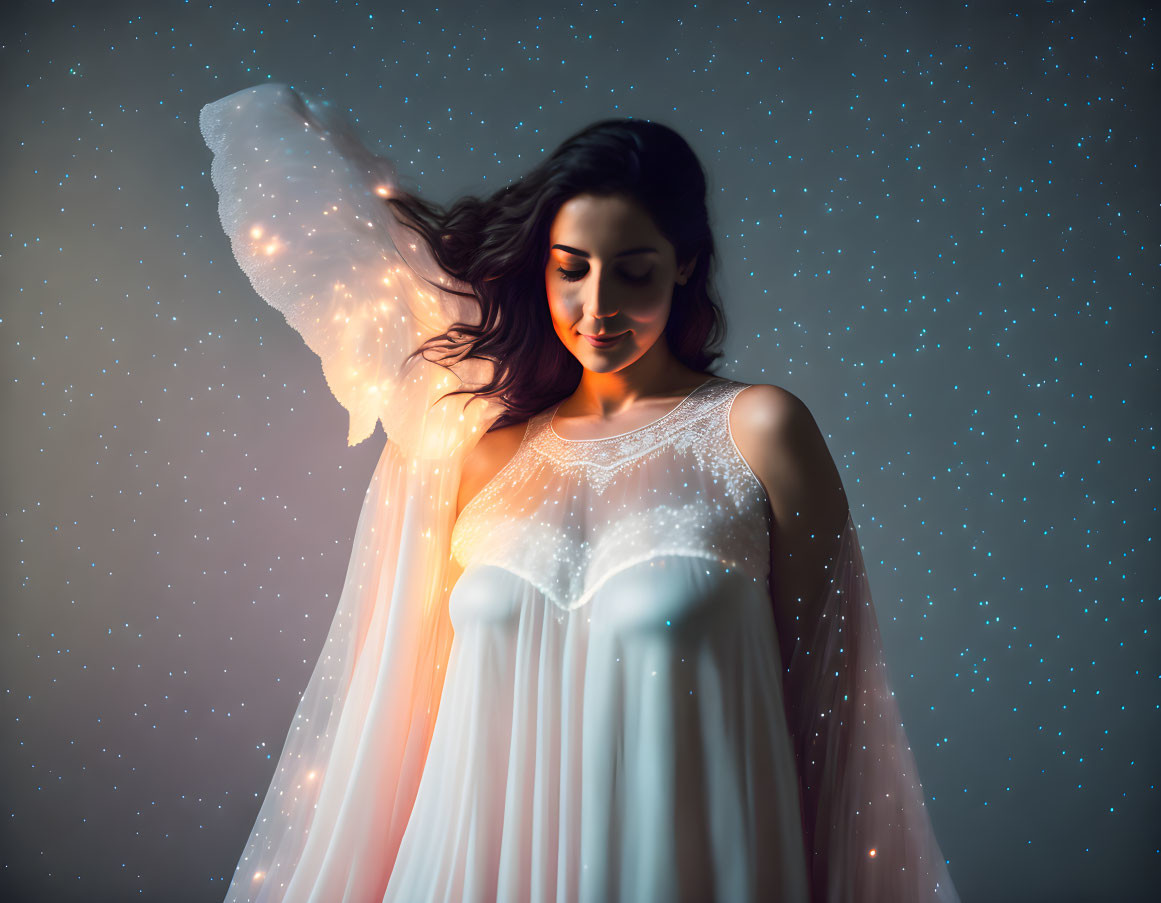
[{"xmin": 201, "ymin": 85, "xmax": 957, "ymax": 903}]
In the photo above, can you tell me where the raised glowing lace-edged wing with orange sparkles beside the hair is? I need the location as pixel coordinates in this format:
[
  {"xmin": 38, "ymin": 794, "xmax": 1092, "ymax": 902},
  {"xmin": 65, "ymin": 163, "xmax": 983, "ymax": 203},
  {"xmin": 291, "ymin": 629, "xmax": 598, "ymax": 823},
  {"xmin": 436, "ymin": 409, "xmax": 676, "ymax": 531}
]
[{"xmin": 199, "ymin": 84, "xmax": 499, "ymax": 457}]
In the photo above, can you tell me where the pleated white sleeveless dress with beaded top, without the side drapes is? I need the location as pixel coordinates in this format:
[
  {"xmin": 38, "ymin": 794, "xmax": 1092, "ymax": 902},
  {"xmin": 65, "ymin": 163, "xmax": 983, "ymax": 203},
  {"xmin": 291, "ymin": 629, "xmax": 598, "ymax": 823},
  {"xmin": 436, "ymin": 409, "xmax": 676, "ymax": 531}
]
[{"xmin": 383, "ymin": 377, "xmax": 808, "ymax": 903}]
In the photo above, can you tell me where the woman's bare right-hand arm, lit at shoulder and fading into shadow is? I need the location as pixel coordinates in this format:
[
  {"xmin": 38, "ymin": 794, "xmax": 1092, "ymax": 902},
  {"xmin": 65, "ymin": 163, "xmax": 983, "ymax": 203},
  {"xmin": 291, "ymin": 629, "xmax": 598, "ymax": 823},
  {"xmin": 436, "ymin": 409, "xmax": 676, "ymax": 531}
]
[{"xmin": 730, "ymin": 383, "xmax": 848, "ymax": 667}]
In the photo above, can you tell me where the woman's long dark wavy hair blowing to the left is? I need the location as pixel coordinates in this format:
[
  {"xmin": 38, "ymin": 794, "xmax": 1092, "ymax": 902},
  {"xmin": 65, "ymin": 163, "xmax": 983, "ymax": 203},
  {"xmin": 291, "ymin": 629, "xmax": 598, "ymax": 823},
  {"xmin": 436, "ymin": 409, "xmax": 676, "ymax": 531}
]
[{"xmin": 385, "ymin": 118, "xmax": 726, "ymax": 429}]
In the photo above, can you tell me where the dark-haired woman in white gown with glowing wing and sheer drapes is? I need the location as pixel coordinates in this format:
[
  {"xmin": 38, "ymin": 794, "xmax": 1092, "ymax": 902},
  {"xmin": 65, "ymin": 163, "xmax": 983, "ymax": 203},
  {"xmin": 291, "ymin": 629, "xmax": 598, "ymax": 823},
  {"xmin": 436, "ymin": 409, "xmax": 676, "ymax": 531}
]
[{"xmin": 201, "ymin": 85, "xmax": 957, "ymax": 903}]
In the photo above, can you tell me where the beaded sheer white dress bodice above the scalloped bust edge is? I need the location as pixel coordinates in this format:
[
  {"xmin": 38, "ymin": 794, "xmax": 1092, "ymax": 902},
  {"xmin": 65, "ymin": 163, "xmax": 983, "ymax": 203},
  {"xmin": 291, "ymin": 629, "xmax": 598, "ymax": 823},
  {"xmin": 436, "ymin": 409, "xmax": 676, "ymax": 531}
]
[{"xmin": 452, "ymin": 376, "xmax": 771, "ymax": 609}]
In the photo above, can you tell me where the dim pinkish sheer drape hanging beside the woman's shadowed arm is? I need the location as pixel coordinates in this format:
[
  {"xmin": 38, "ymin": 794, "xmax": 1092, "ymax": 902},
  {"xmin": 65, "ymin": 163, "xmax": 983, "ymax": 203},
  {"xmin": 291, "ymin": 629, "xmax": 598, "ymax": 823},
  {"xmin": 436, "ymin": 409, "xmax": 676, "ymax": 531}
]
[{"xmin": 785, "ymin": 513, "xmax": 959, "ymax": 903}]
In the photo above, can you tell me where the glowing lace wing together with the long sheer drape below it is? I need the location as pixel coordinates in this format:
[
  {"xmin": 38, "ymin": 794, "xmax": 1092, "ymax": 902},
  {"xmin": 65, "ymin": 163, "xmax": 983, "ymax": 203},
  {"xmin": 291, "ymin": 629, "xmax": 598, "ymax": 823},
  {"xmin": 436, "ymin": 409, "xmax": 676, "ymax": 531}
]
[{"xmin": 201, "ymin": 84, "xmax": 500, "ymax": 903}]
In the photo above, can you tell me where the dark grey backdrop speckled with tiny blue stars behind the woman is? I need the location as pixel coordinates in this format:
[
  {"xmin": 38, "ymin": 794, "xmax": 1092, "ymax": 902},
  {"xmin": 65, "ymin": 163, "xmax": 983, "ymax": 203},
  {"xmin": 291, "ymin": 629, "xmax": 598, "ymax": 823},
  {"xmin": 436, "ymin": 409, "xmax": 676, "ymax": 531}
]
[{"xmin": 0, "ymin": 0, "xmax": 1161, "ymax": 903}]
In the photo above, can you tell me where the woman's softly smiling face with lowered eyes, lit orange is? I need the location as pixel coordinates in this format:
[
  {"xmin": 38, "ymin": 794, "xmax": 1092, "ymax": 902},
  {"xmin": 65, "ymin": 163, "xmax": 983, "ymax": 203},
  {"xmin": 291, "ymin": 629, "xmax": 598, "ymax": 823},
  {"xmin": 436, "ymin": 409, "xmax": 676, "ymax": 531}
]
[{"xmin": 545, "ymin": 194, "xmax": 695, "ymax": 373}]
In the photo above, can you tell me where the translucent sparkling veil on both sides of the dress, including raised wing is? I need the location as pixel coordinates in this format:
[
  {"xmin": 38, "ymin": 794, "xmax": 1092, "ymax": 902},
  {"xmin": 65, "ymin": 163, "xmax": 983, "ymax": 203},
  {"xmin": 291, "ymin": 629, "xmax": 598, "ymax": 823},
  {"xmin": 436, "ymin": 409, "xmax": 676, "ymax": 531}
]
[{"xmin": 200, "ymin": 84, "xmax": 958, "ymax": 903}]
